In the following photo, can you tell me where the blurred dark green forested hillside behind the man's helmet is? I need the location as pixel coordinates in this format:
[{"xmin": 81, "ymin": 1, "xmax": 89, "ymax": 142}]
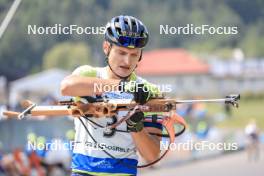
[{"xmin": 0, "ymin": 0, "xmax": 264, "ymax": 80}]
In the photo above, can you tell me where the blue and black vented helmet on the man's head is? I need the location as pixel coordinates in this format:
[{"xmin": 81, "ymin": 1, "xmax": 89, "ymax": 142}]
[{"xmin": 105, "ymin": 15, "xmax": 149, "ymax": 48}]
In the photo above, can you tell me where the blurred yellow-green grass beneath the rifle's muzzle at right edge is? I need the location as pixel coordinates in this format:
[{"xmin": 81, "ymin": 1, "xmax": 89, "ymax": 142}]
[{"xmin": 207, "ymin": 99, "xmax": 264, "ymax": 130}]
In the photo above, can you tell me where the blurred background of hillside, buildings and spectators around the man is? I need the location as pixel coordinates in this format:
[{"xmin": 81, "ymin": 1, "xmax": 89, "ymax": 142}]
[{"xmin": 0, "ymin": 0, "xmax": 264, "ymax": 176}]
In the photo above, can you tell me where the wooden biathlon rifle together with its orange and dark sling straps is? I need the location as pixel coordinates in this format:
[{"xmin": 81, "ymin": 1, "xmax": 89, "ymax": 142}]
[{"xmin": 3, "ymin": 95, "xmax": 240, "ymax": 168}]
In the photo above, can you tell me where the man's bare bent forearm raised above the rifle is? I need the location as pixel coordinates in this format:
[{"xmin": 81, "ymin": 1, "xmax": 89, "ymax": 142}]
[{"xmin": 60, "ymin": 75, "xmax": 120, "ymax": 96}]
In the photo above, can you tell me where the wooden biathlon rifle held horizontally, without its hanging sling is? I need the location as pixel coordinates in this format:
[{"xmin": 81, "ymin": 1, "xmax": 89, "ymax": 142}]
[{"xmin": 3, "ymin": 95, "xmax": 240, "ymax": 119}]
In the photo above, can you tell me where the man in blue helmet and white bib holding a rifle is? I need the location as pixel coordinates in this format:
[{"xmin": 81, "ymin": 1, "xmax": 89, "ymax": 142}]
[{"xmin": 61, "ymin": 16, "xmax": 162, "ymax": 176}]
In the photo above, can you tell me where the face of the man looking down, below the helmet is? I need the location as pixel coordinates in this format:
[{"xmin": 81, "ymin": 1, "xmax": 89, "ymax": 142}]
[{"xmin": 103, "ymin": 42, "xmax": 141, "ymax": 77}]
